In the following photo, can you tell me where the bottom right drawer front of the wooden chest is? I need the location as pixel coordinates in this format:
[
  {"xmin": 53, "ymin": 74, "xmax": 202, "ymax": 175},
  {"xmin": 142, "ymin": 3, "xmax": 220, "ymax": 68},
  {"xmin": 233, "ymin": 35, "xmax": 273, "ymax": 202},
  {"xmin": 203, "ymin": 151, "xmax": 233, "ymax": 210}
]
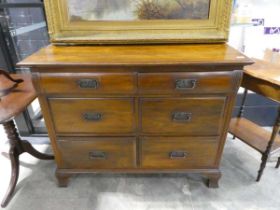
[{"xmin": 141, "ymin": 137, "xmax": 218, "ymax": 169}]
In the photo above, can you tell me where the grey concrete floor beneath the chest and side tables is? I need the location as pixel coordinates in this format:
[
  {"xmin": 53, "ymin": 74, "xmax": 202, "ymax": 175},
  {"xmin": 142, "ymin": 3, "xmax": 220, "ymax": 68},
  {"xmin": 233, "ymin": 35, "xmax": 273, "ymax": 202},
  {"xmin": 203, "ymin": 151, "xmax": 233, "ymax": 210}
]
[{"xmin": 0, "ymin": 126, "xmax": 280, "ymax": 210}]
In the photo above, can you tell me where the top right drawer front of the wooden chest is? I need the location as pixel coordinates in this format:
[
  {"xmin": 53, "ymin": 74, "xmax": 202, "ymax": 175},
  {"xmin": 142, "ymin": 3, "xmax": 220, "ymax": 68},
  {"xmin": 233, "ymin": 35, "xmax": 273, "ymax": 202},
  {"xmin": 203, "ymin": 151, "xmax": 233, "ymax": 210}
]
[{"xmin": 138, "ymin": 72, "xmax": 233, "ymax": 94}]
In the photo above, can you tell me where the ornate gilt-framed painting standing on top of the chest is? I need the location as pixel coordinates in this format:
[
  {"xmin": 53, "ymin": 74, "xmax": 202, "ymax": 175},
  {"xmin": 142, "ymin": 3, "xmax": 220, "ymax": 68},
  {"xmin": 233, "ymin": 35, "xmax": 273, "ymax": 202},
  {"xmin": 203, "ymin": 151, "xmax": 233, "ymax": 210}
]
[{"xmin": 44, "ymin": 0, "xmax": 232, "ymax": 44}]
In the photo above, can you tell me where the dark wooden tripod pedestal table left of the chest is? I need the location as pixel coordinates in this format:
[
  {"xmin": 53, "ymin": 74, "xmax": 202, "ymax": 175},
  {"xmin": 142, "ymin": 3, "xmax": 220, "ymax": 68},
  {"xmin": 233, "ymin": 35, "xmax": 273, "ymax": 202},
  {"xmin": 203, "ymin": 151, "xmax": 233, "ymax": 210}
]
[{"xmin": 0, "ymin": 70, "xmax": 54, "ymax": 207}]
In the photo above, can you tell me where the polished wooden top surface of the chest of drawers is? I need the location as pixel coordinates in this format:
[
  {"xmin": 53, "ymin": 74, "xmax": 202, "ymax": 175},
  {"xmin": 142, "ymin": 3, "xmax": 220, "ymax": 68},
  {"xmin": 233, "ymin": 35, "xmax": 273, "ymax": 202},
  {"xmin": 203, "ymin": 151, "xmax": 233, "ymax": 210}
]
[{"xmin": 18, "ymin": 44, "xmax": 252, "ymax": 67}]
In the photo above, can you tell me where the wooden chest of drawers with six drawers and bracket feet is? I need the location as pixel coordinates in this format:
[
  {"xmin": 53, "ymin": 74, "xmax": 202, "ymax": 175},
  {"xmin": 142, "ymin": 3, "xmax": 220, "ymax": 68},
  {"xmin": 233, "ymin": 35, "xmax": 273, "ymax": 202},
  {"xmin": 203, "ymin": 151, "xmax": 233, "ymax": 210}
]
[{"xmin": 19, "ymin": 44, "xmax": 251, "ymax": 187}]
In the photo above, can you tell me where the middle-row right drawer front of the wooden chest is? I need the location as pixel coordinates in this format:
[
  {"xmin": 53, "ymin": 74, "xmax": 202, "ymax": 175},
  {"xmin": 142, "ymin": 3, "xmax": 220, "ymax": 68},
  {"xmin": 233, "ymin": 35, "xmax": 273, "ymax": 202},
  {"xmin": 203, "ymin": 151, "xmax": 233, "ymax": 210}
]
[{"xmin": 140, "ymin": 97, "xmax": 225, "ymax": 136}]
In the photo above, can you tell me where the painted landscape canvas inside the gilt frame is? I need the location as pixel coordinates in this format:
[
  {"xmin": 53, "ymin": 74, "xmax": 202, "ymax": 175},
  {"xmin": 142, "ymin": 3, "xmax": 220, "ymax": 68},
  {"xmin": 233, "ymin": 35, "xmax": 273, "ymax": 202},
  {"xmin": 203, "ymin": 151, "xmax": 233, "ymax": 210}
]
[{"xmin": 67, "ymin": 0, "xmax": 211, "ymax": 21}]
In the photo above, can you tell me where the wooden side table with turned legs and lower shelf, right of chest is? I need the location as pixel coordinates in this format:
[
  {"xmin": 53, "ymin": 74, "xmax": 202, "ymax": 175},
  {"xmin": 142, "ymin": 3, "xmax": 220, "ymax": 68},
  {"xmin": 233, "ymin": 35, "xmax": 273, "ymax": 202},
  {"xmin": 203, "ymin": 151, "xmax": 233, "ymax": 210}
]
[{"xmin": 229, "ymin": 59, "xmax": 280, "ymax": 181}]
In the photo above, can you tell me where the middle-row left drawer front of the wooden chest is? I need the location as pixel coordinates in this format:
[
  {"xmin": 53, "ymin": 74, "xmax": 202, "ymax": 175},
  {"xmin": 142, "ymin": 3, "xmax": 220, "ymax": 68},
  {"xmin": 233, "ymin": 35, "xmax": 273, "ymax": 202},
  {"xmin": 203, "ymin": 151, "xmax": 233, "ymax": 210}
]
[{"xmin": 49, "ymin": 98, "xmax": 135, "ymax": 134}]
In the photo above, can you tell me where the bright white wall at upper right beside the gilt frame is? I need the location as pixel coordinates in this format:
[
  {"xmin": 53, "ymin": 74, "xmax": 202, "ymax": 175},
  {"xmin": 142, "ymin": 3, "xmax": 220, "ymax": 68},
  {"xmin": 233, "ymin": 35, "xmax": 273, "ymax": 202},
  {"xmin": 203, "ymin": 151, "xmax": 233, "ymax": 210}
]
[{"xmin": 229, "ymin": 0, "xmax": 280, "ymax": 58}]
